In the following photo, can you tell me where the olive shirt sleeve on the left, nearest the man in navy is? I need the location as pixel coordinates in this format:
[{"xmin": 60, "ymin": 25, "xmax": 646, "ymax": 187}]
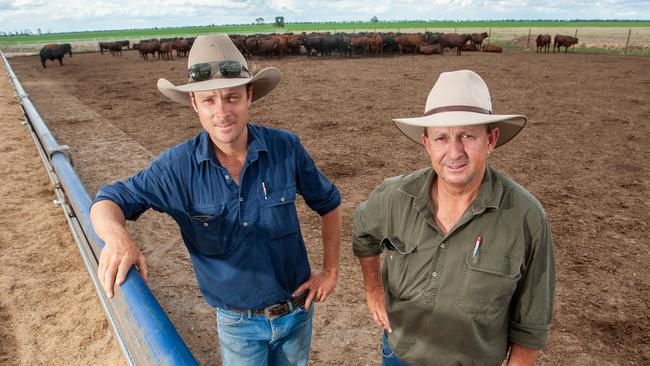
[{"xmin": 352, "ymin": 185, "xmax": 388, "ymax": 257}]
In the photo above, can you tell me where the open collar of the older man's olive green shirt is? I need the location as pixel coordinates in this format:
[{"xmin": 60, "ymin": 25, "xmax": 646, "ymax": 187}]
[{"xmin": 400, "ymin": 165, "xmax": 503, "ymax": 214}]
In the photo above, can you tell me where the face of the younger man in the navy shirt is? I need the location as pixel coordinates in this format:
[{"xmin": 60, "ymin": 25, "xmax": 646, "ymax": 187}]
[{"xmin": 190, "ymin": 85, "xmax": 253, "ymax": 145}]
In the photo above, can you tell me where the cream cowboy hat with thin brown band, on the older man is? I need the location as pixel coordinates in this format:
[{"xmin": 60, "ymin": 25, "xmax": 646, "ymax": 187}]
[{"xmin": 393, "ymin": 70, "xmax": 527, "ymax": 147}]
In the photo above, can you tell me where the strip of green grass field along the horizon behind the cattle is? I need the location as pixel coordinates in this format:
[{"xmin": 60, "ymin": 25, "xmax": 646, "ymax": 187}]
[{"xmin": 0, "ymin": 21, "xmax": 650, "ymax": 46}]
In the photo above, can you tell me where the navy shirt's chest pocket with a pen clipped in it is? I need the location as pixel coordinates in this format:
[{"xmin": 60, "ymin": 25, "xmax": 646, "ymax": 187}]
[{"xmin": 260, "ymin": 185, "xmax": 300, "ymax": 239}]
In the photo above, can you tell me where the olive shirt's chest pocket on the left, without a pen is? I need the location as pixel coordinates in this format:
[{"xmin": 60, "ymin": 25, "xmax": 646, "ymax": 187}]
[{"xmin": 382, "ymin": 237, "xmax": 417, "ymax": 301}]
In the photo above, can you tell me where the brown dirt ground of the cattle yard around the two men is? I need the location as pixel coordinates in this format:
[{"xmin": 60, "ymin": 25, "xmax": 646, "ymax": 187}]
[{"xmin": 5, "ymin": 48, "xmax": 650, "ymax": 365}]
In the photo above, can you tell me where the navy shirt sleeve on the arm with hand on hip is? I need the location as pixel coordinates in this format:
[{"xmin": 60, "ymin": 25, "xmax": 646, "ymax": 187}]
[{"xmin": 294, "ymin": 137, "xmax": 341, "ymax": 216}]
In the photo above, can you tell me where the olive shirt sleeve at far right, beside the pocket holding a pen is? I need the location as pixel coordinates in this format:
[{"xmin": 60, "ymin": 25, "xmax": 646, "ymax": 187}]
[{"xmin": 508, "ymin": 216, "xmax": 555, "ymax": 349}]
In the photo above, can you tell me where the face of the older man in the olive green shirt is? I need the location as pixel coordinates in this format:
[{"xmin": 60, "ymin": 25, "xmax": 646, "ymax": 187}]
[{"xmin": 422, "ymin": 125, "xmax": 499, "ymax": 191}]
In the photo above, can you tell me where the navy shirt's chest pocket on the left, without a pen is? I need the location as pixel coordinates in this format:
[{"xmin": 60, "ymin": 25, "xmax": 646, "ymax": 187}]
[{"xmin": 185, "ymin": 203, "xmax": 234, "ymax": 256}]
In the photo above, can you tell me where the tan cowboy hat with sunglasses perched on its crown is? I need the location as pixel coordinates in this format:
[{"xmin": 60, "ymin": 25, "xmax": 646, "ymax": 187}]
[{"xmin": 158, "ymin": 34, "xmax": 282, "ymax": 105}]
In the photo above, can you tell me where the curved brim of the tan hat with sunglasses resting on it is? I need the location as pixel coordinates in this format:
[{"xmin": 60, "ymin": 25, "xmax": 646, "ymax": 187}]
[{"xmin": 158, "ymin": 67, "xmax": 282, "ymax": 105}]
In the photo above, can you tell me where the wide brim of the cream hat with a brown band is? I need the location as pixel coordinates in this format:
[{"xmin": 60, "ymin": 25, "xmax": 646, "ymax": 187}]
[{"xmin": 393, "ymin": 111, "xmax": 528, "ymax": 147}]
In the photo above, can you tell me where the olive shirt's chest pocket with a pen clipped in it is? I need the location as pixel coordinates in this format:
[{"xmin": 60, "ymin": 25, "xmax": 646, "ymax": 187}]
[{"xmin": 457, "ymin": 248, "xmax": 522, "ymax": 315}]
